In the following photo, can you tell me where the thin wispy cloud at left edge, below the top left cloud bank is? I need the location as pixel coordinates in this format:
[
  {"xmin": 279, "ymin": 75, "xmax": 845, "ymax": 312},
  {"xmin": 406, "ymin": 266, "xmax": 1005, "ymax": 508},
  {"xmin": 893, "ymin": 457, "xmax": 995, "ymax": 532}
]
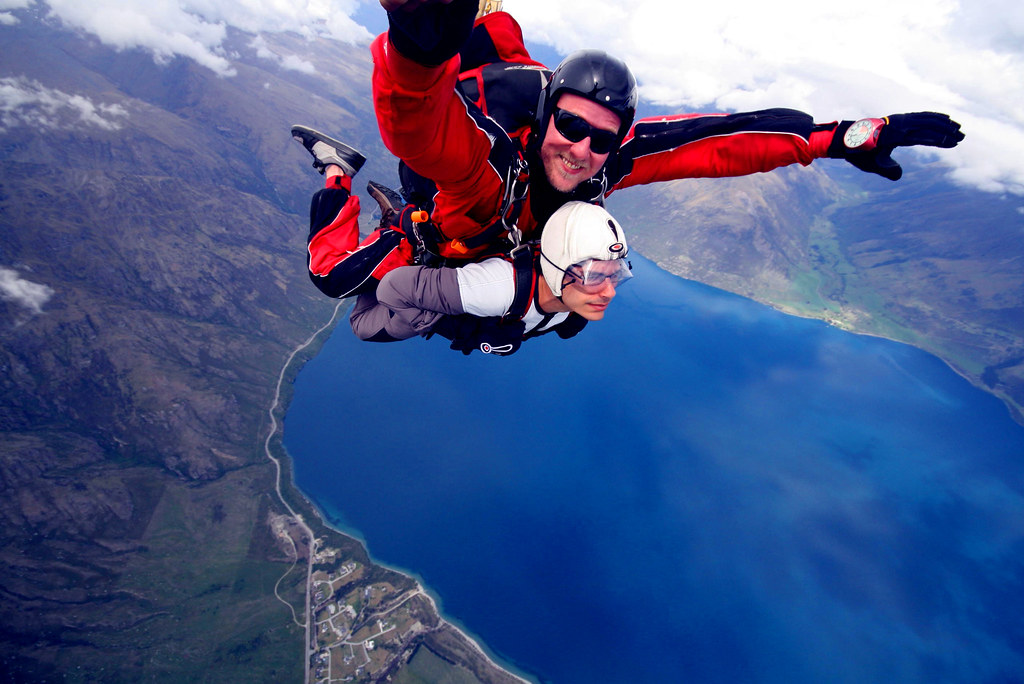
[{"xmin": 0, "ymin": 77, "xmax": 128, "ymax": 131}]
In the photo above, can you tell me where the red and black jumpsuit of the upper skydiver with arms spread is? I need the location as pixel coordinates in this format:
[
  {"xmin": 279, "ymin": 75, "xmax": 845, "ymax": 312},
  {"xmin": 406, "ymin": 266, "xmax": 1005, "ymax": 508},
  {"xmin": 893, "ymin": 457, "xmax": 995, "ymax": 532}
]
[{"xmin": 309, "ymin": 0, "xmax": 837, "ymax": 329}]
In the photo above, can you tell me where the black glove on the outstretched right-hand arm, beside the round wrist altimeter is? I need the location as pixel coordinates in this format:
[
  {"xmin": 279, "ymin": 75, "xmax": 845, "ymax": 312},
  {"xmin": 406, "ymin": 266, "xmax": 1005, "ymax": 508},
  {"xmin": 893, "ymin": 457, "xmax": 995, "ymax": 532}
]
[{"xmin": 828, "ymin": 112, "xmax": 964, "ymax": 180}]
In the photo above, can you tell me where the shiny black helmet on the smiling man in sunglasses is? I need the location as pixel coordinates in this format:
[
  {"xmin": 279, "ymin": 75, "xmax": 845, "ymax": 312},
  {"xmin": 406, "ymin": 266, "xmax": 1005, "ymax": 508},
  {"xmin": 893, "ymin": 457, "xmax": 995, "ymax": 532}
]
[{"xmin": 537, "ymin": 50, "xmax": 638, "ymax": 150}]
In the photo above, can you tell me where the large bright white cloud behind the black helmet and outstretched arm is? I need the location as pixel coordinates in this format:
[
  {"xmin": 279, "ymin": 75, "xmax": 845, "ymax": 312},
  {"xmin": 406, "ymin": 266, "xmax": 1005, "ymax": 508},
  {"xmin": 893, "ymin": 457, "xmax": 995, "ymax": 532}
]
[{"xmin": 505, "ymin": 0, "xmax": 1024, "ymax": 195}]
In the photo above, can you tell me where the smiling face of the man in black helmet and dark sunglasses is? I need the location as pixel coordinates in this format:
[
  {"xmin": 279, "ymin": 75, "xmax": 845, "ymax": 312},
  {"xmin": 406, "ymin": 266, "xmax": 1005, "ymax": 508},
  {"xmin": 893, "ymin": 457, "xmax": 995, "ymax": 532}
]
[{"xmin": 541, "ymin": 92, "xmax": 621, "ymax": 193}]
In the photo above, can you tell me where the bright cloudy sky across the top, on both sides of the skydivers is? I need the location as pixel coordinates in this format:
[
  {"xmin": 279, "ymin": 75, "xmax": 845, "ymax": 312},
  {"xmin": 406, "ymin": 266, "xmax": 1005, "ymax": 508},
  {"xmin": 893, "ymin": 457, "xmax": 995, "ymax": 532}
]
[{"xmin": 6, "ymin": 0, "xmax": 1024, "ymax": 197}]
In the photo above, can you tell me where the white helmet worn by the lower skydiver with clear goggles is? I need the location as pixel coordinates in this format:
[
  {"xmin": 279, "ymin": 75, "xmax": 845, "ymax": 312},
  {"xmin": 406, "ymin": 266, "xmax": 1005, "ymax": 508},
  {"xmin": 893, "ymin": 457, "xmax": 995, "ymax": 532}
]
[{"xmin": 541, "ymin": 202, "xmax": 631, "ymax": 297}]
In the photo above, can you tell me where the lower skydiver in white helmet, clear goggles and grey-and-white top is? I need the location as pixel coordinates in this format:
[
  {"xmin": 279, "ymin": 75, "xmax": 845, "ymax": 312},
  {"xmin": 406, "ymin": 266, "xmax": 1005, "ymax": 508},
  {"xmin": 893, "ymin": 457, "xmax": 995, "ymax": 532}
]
[{"xmin": 351, "ymin": 202, "xmax": 632, "ymax": 354}]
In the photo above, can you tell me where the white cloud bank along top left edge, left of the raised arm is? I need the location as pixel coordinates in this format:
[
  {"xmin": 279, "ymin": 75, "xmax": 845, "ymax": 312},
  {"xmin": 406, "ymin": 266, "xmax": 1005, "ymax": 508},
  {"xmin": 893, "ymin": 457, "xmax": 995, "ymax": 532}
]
[{"xmin": 46, "ymin": 0, "xmax": 371, "ymax": 77}]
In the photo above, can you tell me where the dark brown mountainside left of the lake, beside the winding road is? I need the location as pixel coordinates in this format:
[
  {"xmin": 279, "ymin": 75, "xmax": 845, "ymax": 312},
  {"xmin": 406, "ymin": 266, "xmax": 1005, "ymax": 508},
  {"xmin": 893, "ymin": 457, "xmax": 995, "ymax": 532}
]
[{"xmin": 0, "ymin": 12, "xmax": 516, "ymax": 682}]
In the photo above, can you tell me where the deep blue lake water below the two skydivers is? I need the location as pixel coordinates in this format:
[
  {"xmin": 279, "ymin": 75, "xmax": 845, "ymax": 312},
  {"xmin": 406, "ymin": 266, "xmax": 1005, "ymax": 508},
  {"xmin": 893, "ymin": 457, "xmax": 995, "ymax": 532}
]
[{"xmin": 285, "ymin": 258, "xmax": 1024, "ymax": 684}]
